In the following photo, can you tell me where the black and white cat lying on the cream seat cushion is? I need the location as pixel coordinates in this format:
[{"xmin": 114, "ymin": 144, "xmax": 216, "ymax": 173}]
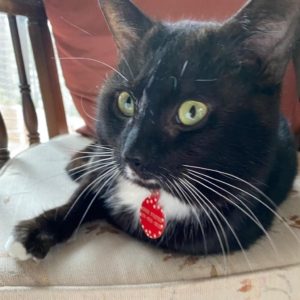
[{"xmin": 5, "ymin": 0, "xmax": 299, "ymax": 258}]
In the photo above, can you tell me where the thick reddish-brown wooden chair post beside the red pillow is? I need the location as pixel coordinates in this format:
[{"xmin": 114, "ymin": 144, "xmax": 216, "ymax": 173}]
[{"xmin": 28, "ymin": 18, "xmax": 68, "ymax": 137}]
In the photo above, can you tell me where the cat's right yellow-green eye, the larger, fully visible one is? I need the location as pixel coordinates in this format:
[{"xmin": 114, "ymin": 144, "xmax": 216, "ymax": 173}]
[{"xmin": 178, "ymin": 100, "xmax": 208, "ymax": 126}]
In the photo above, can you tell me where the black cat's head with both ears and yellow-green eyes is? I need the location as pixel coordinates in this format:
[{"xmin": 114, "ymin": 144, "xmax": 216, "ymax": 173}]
[{"xmin": 97, "ymin": 0, "xmax": 299, "ymax": 189}]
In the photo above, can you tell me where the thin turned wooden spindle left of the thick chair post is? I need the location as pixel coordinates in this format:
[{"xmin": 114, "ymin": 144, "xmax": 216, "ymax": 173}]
[{"xmin": 8, "ymin": 15, "xmax": 40, "ymax": 145}]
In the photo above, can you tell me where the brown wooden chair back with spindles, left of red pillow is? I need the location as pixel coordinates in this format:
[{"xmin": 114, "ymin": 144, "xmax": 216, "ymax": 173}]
[{"xmin": 0, "ymin": 0, "xmax": 68, "ymax": 168}]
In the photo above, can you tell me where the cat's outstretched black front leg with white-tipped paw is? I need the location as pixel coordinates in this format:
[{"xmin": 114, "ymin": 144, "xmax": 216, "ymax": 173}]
[{"xmin": 6, "ymin": 179, "xmax": 104, "ymax": 260}]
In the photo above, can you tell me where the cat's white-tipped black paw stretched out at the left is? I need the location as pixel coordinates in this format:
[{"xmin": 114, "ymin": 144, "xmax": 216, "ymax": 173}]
[{"xmin": 5, "ymin": 220, "xmax": 56, "ymax": 261}]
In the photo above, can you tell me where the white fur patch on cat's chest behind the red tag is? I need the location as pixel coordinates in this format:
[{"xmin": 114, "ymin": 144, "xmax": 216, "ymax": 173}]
[{"xmin": 106, "ymin": 178, "xmax": 192, "ymax": 224}]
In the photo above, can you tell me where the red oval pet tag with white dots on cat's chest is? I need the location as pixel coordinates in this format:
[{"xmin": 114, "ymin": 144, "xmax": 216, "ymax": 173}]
[{"xmin": 140, "ymin": 192, "xmax": 166, "ymax": 240}]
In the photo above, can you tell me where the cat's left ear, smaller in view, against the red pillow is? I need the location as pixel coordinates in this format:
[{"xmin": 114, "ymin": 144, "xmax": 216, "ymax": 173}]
[{"xmin": 99, "ymin": 0, "xmax": 153, "ymax": 51}]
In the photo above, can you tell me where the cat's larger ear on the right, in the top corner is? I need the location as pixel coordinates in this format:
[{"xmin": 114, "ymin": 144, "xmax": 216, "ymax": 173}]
[{"xmin": 223, "ymin": 0, "xmax": 300, "ymax": 84}]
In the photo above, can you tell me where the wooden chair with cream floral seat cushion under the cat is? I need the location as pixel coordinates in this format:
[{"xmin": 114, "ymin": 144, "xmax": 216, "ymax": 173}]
[{"xmin": 0, "ymin": 0, "xmax": 300, "ymax": 300}]
